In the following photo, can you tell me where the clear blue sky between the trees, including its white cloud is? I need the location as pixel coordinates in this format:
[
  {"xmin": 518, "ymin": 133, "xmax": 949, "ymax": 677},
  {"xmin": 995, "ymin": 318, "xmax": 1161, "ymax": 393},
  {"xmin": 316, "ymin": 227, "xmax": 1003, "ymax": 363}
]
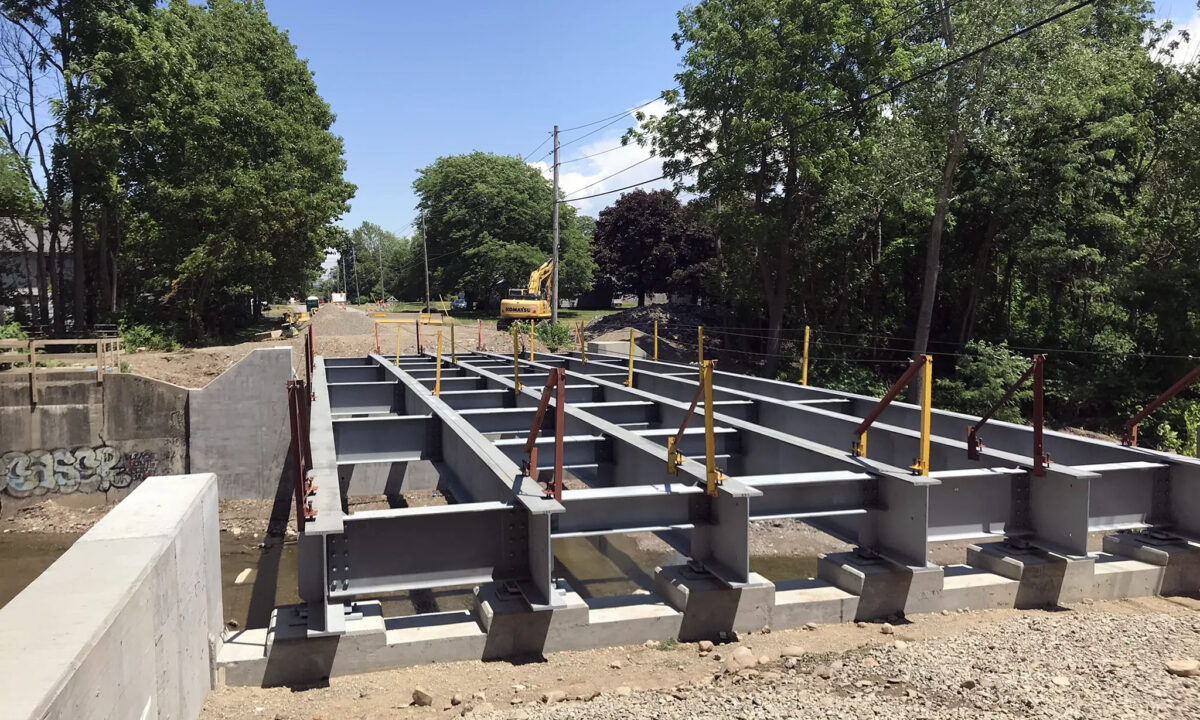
[{"xmin": 266, "ymin": 0, "xmax": 1200, "ymax": 244}]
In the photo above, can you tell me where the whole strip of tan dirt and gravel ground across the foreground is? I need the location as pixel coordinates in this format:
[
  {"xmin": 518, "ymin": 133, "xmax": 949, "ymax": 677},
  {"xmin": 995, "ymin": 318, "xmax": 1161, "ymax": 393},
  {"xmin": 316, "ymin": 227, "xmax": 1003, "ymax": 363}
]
[{"xmin": 202, "ymin": 598, "xmax": 1200, "ymax": 720}]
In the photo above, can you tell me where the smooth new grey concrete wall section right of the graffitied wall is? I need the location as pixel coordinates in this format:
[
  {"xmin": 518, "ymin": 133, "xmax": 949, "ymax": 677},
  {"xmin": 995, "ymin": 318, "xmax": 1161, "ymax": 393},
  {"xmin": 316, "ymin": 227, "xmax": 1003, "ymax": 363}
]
[{"xmin": 188, "ymin": 347, "xmax": 292, "ymax": 499}]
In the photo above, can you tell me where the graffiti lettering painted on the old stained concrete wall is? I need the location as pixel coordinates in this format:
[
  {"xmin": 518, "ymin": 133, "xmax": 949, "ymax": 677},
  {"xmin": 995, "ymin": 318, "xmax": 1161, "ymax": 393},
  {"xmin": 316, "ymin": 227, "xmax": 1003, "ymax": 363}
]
[{"xmin": 0, "ymin": 445, "xmax": 158, "ymax": 498}]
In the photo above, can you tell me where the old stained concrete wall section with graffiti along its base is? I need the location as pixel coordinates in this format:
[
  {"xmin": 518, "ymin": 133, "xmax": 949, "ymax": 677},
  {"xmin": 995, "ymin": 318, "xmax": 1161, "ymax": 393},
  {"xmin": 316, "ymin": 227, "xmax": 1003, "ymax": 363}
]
[{"xmin": 0, "ymin": 372, "xmax": 188, "ymax": 516}]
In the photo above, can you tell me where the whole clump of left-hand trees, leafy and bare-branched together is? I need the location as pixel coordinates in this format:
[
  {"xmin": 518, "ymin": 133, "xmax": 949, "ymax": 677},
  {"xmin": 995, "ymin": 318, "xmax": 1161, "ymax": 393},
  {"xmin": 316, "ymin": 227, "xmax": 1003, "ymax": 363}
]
[{"xmin": 0, "ymin": 0, "xmax": 354, "ymax": 332}]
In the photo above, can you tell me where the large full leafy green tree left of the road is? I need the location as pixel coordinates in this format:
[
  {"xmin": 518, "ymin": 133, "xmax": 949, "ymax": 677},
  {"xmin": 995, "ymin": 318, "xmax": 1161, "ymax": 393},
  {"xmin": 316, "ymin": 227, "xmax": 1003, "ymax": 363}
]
[{"xmin": 121, "ymin": 0, "xmax": 354, "ymax": 331}]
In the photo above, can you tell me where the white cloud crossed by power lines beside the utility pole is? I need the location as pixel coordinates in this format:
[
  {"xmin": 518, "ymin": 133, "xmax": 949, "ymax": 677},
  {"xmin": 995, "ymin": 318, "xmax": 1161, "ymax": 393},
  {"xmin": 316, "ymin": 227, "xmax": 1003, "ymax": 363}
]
[{"xmin": 529, "ymin": 98, "xmax": 691, "ymax": 217}]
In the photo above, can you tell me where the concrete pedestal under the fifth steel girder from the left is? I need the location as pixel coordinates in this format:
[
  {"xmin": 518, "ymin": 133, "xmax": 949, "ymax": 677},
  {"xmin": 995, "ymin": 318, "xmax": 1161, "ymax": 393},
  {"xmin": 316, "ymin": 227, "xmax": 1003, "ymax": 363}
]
[{"xmin": 967, "ymin": 542, "xmax": 1096, "ymax": 607}]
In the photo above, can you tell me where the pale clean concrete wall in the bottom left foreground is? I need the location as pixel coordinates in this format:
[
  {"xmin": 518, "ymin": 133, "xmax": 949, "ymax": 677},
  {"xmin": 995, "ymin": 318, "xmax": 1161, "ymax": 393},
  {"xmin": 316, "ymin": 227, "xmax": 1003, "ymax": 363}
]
[{"xmin": 0, "ymin": 474, "xmax": 223, "ymax": 720}]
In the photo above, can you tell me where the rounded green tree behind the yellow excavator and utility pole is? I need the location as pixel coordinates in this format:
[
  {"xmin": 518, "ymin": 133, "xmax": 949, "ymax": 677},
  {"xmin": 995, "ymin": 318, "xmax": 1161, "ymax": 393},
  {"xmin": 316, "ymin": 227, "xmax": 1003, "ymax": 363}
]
[{"xmin": 413, "ymin": 152, "xmax": 595, "ymax": 305}]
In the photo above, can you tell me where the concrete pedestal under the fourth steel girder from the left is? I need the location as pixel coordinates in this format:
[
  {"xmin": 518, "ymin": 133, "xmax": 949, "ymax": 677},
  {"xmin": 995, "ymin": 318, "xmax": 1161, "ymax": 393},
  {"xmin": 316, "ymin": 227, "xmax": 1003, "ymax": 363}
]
[{"xmin": 817, "ymin": 552, "xmax": 943, "ymax": 620}]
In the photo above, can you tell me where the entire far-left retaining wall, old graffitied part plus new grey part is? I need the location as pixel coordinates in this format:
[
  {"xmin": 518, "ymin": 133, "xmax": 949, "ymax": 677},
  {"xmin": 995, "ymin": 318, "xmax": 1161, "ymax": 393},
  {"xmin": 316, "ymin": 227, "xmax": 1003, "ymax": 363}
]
[{"xmin": 0, "ymin": 347, "xmax": 292, "ymax": 508}]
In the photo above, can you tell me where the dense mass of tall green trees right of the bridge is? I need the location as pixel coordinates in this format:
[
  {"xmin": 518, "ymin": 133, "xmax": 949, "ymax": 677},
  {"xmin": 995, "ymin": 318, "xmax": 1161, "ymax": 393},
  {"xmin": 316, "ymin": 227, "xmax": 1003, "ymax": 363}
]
[{"xmin": 637, "ymin": 0, "xmax": 1200, "ymax": 443}]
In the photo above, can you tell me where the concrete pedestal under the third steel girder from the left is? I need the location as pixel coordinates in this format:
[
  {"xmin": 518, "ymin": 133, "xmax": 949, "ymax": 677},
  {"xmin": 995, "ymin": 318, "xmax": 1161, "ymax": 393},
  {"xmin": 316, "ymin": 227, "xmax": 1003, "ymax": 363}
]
[{"xmin": 654, "ymin": 565, "xmax": 775, "ymax": 642}]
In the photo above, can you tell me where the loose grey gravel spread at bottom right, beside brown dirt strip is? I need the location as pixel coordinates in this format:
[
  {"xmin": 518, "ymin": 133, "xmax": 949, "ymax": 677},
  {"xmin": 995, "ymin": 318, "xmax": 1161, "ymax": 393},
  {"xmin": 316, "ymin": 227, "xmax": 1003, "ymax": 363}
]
[{"xmin": 482, "ymin": 611, "xmax": 1200, "ymax": 720}]
